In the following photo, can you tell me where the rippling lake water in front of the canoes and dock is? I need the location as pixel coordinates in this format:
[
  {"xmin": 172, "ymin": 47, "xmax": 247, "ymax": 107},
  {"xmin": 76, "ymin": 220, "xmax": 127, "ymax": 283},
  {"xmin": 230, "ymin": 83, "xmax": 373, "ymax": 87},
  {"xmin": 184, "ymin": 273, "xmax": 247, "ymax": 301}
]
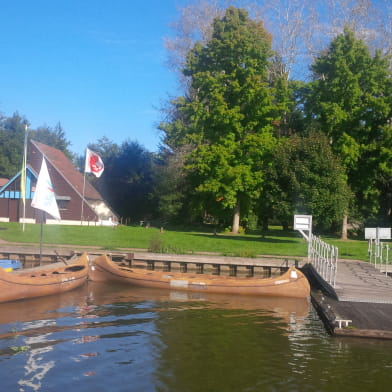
[{"xmin": 0, "ymin": 283, "xmax": 392, "ymax": 392}]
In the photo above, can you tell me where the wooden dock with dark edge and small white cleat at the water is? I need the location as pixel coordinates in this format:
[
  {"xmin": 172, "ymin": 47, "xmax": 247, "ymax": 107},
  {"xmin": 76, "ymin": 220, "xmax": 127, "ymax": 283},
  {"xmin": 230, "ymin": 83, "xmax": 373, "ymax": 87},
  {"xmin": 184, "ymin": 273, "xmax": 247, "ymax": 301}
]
[{"xmin": 305, "ymin": 260, "xmax": 392, "ymax": 339}]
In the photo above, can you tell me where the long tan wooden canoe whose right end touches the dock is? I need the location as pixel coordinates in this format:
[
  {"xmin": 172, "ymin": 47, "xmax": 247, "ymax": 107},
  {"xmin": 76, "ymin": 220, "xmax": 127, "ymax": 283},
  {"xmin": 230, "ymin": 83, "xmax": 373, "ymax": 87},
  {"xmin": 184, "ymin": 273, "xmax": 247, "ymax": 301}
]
[{"xmin": 89, "ymin": 255, "xmax": 310, "ymax": 298}]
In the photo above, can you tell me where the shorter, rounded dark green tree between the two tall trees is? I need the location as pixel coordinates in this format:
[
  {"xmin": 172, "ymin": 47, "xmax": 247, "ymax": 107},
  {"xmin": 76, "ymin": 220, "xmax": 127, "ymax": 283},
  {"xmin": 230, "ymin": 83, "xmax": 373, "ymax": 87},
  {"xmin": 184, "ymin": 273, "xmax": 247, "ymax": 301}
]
[{"xmin": 260, "ymin": 132, "xmax": 351, "ymax": 231}]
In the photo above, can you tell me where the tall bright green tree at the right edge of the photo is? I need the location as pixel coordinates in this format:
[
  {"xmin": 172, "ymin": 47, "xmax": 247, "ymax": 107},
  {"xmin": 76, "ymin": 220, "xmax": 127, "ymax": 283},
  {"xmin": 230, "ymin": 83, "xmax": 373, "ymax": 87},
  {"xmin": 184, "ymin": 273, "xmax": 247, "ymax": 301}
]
[{"xmin": 306, "ymin": 29, "xmax": 392, "ymax": 238}]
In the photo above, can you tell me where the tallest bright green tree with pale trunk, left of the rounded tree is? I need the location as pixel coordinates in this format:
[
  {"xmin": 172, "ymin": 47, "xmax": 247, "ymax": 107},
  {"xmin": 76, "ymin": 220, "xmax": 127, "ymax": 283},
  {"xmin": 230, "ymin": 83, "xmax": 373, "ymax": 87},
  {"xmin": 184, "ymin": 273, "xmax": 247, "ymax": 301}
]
[{"xmin": 161, "ymin": 7, "xmax": 274, "ymax": 233}]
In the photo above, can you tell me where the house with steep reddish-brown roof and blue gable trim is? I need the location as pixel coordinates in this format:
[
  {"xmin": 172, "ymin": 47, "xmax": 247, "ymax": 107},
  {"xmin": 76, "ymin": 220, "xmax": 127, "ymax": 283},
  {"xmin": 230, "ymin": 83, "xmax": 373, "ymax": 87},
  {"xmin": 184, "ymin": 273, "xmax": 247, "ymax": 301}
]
[{"xmin": 0, "ymin": 140, "xmax": 117, "ymax": 224}]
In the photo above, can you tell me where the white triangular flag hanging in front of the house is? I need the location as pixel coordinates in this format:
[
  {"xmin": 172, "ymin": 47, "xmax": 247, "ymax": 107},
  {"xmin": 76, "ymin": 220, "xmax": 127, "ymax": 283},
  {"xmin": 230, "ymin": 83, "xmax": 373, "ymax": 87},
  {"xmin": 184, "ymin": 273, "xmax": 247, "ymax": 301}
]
[{"xmin": 31, "ymin": 157, "xmax": 61, "ymax": 220}]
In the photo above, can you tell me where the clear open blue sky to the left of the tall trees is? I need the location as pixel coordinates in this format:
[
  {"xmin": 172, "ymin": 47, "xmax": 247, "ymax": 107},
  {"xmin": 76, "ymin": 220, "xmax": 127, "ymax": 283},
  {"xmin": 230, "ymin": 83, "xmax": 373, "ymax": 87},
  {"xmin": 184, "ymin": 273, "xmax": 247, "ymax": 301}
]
[{"xmin": 0, "ymin": 0, "xmax": 184, "ymax": 154}]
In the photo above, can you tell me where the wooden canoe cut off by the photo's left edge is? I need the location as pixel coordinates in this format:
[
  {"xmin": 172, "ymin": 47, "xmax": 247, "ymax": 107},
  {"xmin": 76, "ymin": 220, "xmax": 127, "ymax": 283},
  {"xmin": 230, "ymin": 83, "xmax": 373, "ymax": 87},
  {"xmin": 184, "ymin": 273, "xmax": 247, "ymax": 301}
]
[{"xmin": 0, "ymin": 253, "xmax": 88, "ymax": 302}]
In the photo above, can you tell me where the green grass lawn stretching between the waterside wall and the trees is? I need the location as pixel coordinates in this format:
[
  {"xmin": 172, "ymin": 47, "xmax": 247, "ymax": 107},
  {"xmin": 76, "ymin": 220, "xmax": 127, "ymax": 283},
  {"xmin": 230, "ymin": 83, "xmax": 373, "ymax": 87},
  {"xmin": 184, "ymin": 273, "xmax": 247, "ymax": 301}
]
[{"xmin": 0, "ymin": 223, "xmax": 368, "ymax": 261}]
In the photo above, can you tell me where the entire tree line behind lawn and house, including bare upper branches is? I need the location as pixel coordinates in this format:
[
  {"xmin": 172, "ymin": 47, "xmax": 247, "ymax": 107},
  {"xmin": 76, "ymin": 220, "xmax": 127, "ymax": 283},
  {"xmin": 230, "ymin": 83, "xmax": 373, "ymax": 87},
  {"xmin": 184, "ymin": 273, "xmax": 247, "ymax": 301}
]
[{"xmin": 0, "ymin": 0, "xmax": 392, "ymax": 233}]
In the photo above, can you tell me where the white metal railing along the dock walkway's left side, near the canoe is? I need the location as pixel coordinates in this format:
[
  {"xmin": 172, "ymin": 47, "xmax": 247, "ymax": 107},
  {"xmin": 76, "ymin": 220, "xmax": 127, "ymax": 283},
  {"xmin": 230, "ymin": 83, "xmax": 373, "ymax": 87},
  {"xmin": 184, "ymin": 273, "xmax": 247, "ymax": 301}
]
[{"xmin": 308, "ymin": 234, "xmax": 338, "ymax": 287}]
